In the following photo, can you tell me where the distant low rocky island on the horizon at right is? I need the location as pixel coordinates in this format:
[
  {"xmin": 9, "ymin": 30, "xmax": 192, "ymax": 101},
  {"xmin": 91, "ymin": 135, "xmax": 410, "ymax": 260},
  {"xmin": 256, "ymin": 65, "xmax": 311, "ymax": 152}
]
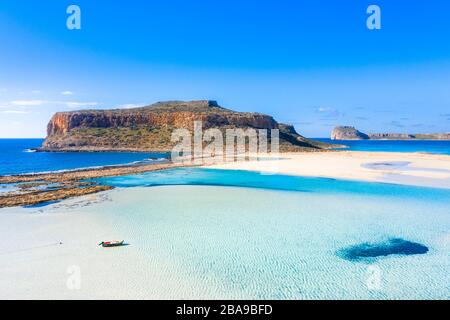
[{"xmin": 331, "ymin": 126, "xmax": 450, "ymax": 140}]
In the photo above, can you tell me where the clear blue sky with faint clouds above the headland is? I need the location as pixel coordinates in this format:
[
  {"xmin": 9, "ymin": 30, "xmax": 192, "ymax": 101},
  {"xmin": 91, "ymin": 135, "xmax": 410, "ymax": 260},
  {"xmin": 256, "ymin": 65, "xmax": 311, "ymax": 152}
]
[{"xmin": 0, "ymin": 0, "xmax": 450, "ymax": 137}]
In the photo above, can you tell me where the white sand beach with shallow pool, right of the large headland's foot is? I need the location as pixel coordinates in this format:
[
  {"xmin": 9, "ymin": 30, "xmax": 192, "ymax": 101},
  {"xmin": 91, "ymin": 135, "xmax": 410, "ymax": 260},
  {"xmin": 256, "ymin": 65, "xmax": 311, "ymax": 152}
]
[{"xmin": 209, "ymin": 151, "xmax": 450, "ymax": 188}]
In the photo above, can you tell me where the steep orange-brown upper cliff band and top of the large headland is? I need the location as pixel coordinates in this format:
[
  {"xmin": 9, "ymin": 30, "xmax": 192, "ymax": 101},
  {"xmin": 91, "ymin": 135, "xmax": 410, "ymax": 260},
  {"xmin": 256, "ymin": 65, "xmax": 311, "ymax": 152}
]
[{"xmin": 47, "ymin": 101, "xmax": 277, "ymax": 137}]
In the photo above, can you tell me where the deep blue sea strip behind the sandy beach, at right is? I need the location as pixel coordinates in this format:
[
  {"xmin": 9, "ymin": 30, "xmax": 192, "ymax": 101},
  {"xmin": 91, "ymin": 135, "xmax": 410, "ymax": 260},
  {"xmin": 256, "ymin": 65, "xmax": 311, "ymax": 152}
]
[{"xmin": 316, "ymin": 138, "xmax": 450, "ymax": 154}]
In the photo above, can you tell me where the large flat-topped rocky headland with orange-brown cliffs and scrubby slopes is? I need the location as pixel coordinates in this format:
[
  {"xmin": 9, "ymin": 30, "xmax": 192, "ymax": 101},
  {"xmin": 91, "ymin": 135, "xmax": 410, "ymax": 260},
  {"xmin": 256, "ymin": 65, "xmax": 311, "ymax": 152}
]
[{"xmin": 42, "ymin": 100, "xmax": 329, "ymax": 151}]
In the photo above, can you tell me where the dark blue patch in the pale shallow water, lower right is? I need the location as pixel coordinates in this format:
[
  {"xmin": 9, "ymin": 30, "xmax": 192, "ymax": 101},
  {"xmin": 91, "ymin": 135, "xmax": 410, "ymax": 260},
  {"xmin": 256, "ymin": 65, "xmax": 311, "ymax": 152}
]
[{"xmin": 337, "ymin": 238, "xmax": 428, "ymax": 261}]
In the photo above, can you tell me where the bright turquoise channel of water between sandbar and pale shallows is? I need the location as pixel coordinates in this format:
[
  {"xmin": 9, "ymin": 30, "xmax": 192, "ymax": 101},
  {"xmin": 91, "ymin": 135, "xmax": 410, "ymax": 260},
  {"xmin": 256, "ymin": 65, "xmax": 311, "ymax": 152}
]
[{"xmin": 96, "ymin": 168, "xmax": 450, "ymax": 202}]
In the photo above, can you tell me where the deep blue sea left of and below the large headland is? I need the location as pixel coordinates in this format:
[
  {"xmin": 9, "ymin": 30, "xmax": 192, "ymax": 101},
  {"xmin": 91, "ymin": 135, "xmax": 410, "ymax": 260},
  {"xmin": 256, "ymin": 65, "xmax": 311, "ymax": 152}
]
[{"xmin": 0, "ymin": 139, "xmax": 167, "ymax": 175}]
